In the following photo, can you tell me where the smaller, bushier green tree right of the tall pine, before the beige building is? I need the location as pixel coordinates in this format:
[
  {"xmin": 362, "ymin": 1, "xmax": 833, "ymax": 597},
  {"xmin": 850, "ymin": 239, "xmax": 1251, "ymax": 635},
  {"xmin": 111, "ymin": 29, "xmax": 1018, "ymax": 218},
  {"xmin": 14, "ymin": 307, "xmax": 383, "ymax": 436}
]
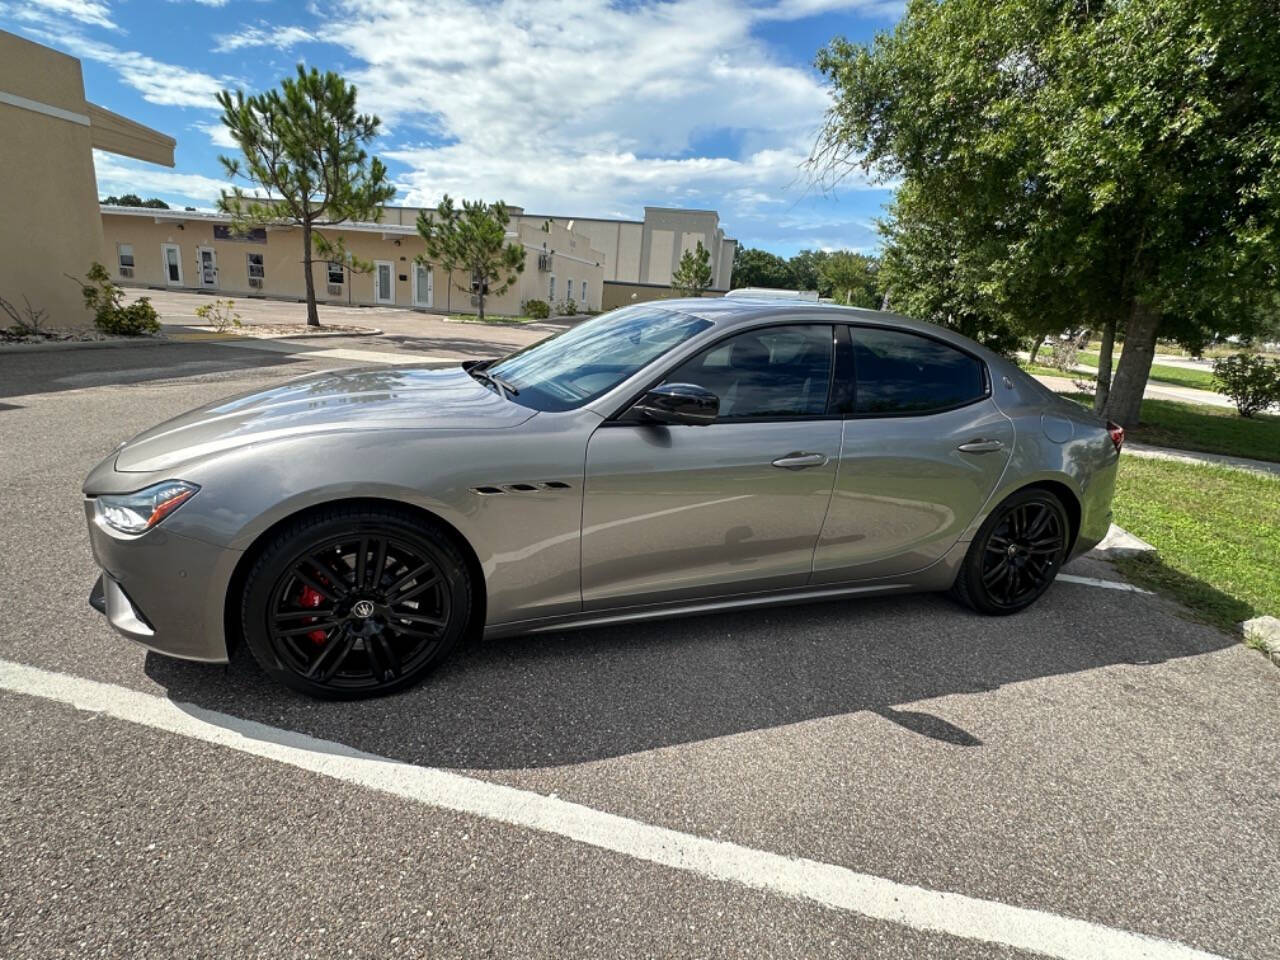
[{"xmin": 417, "ymin": 193, "xmax": 525, "ymax": 320}]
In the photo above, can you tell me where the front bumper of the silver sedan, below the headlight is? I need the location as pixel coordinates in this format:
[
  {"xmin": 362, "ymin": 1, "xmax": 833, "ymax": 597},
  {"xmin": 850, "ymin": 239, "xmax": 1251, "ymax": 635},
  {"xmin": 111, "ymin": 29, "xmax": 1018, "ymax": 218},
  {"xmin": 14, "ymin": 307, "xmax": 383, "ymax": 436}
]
[{"xmin": 84, "ymin": 498, "xmax": 241, "ymax": 663}]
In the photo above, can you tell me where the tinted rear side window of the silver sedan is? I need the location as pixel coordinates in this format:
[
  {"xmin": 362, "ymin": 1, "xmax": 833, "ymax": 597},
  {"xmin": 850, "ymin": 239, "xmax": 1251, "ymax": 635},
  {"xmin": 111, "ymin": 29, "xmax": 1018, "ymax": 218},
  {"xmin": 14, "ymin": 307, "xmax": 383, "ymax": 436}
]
[{"xmin": 851, "ymin": 328, "xmax": 987, "ymax": 413}]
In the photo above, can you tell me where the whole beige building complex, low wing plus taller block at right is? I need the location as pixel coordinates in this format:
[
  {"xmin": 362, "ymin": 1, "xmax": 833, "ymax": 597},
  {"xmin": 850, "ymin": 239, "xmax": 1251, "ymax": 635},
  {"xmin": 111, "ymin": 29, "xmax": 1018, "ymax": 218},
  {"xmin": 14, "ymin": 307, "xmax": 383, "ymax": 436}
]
[{"xmin": 101, "ymin": 206, "xmax": 736, "ymax": 315}]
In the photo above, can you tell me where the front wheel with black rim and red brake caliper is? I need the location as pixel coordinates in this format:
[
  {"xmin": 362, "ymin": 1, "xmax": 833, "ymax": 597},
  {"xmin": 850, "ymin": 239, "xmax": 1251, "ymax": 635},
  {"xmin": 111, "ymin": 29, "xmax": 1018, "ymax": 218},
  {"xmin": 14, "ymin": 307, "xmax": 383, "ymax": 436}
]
[{"xmin": 241, "ymin": 507, "xmax": 474, "ymax": 700}]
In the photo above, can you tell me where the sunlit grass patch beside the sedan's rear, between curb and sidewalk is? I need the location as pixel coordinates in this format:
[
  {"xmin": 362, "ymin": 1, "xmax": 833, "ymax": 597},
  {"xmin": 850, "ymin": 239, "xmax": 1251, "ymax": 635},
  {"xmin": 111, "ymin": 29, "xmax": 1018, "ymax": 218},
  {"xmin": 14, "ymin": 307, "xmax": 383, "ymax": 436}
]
[{"xmin": 1115, "ymin": 457, "xmax": 1280, "ymax": 640}]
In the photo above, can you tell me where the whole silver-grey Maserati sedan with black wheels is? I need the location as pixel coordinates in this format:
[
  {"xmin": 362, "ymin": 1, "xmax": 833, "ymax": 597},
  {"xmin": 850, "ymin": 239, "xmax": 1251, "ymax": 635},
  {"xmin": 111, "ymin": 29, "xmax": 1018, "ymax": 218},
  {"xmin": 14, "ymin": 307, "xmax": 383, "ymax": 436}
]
[{"xmin": 84, "ymin": 297, "xmax": 1123, "ymax": 698}]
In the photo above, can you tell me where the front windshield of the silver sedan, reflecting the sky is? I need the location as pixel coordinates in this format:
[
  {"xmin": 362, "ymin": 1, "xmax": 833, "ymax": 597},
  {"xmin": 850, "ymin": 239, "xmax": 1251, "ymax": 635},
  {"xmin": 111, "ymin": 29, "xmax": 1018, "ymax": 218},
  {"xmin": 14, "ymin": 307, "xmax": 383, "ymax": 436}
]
[{"xmin": 484, "ymin": 303, "xmax": 710, "ymax": 412}]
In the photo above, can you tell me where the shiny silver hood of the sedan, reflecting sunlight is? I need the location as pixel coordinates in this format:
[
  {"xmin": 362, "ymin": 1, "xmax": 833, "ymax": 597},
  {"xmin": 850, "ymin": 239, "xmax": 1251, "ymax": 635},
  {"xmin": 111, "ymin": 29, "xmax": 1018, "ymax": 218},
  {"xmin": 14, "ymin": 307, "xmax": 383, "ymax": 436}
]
[{"xmin": 107, "ymin": 366, "xmax": 534, "ymax": 472}]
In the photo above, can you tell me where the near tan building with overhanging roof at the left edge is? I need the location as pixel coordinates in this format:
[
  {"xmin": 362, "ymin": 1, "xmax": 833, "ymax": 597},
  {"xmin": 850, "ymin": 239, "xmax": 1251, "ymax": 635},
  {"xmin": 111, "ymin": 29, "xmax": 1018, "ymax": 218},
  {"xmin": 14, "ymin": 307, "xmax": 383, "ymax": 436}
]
[{"xmin": 0, "ymin": 31, "xmax": 174, "ymax": 329}]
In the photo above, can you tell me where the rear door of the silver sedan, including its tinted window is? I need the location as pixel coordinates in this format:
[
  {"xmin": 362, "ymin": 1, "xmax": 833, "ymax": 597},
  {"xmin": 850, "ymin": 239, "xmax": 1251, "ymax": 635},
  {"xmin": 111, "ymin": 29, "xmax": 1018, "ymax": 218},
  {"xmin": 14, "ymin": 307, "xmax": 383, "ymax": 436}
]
[{"xmin": 813, "ymin": 326, "xmax": 1014, "ymax": 584}]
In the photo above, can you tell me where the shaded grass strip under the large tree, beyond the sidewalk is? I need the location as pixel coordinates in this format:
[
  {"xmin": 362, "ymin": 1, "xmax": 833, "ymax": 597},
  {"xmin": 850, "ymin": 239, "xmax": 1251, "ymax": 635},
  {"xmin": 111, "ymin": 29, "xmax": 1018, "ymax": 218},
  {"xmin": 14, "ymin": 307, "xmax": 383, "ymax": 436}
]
[{"xmin": 1062, "ymin": 393, "xmax": 1280, "ymax": 463}]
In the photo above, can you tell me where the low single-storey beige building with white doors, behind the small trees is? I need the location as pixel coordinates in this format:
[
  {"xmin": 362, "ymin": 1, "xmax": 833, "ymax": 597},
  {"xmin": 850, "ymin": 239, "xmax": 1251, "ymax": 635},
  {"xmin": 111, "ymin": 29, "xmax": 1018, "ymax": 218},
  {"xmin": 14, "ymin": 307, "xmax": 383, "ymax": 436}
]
[{"xmin": 101, "ymin": 206, "xmax": 604, "ymax": 315}]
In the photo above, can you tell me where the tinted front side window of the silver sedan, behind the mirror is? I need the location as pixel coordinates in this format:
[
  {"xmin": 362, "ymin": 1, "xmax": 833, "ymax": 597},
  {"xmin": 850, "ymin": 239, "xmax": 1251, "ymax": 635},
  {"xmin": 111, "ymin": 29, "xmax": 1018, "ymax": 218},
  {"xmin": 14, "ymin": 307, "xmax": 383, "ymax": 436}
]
[{"xmin": 667, "ymin": 325, "xmax": 832, "ymax": 420}]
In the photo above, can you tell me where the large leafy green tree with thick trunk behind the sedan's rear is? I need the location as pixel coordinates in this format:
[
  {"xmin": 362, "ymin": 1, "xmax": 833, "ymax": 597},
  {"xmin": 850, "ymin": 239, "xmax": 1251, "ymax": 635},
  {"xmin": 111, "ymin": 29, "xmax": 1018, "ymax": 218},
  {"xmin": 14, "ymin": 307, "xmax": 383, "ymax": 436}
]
[{"xmin": 812, "ymin": 0, "xmax": 1280, "ymax": 426}]
